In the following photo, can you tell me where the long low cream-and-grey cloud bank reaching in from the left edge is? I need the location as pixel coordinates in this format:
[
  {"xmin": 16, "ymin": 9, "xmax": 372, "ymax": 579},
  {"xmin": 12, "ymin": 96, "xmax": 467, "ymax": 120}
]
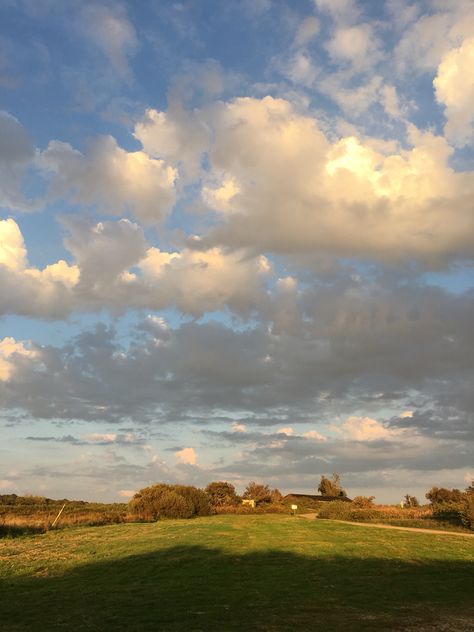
[{"xmin": 0, "ymin": 216, "xmax": 271, "ymax": 318}]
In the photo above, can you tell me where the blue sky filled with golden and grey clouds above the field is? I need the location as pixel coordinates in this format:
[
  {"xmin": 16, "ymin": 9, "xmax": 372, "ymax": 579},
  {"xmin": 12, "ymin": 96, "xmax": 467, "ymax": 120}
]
[{"xmin": 0, "ymin": 0, "xmax": 474, "ymax": 502}]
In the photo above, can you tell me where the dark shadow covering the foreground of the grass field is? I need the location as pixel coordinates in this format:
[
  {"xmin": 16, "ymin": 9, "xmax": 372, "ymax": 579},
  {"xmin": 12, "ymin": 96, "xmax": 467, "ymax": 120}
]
[{"xmin": 0, "ymin": 546, "xmax": 474, "ymax": 632}]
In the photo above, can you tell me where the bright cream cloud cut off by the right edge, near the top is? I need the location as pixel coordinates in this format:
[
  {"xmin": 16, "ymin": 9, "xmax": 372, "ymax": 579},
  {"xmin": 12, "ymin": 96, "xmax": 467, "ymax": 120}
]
[{"xmin": 433, "ymin": 37, "xmax": 474, "ymax": 146}]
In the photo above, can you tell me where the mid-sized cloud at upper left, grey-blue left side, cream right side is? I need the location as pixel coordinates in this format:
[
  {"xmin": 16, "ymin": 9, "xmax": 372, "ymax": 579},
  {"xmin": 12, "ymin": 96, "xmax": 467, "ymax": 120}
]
[{"xmin": 38, "ymin": 136, "xmax": 177, "ymax": 224}]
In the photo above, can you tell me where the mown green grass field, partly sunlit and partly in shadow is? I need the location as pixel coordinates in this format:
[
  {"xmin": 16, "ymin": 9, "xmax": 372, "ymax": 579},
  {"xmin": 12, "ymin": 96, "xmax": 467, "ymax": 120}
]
[{"xmin": 0, "ymin": 515, "xmax": 474, "ymax": 632}]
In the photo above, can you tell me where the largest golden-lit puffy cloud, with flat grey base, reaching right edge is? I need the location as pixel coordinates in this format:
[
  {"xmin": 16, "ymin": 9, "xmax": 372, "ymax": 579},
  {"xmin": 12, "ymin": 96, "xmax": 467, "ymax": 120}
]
[{"xmin": 202, "ymin": 97, "xmax": 474, "ymax": 265}]
